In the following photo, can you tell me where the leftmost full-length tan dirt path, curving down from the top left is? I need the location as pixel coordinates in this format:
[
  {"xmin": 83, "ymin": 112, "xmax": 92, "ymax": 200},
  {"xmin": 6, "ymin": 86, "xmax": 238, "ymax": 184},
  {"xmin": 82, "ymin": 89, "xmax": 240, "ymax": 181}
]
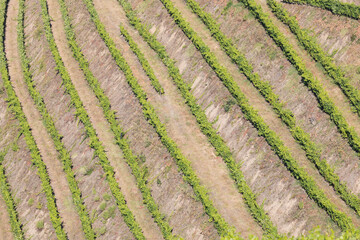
[{"xmin": 5, "ymin": 0, "xmax": 84, "ymax": 240}]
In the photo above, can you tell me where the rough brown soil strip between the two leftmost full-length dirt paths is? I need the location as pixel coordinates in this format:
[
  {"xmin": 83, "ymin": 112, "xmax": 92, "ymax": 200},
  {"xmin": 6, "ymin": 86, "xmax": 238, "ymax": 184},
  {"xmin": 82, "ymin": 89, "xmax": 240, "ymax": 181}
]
[{"xmin": 25, "ymin": 0, "xmax": 133, "ymax": 239}]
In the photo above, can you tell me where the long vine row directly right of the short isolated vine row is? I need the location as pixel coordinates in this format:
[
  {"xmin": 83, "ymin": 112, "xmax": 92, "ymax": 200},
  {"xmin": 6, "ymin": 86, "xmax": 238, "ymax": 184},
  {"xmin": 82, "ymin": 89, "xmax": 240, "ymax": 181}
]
[{"xmin": 119, "ymin": 0, "xmax": 278, "ymax": 236}]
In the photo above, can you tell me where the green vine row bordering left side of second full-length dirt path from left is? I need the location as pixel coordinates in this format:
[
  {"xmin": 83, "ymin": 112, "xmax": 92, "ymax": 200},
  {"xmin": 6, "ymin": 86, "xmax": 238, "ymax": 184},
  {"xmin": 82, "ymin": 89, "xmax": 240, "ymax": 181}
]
[{"xmin": 40, "ymin": 0, "xmax": 145, "ymax": 239}]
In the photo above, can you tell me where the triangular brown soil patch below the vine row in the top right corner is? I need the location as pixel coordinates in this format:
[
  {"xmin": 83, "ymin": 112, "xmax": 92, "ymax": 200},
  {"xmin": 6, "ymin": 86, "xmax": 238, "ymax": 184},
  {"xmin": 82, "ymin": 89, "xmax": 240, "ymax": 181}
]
[{"xmin": 283, "ymin": 4, "xmax": 360, "ymax": 93}]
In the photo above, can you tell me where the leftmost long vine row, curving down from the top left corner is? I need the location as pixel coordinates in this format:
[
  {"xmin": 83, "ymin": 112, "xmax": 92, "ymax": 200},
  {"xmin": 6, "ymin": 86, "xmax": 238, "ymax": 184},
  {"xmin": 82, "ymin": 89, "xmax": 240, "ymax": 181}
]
[{"xmin": 0, "ymin": 0, "xmax": 67, "ymax": 240}]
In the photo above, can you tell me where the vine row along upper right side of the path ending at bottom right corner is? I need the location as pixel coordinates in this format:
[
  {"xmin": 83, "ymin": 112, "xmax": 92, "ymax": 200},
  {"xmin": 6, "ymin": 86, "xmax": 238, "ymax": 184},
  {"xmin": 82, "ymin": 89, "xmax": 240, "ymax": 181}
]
[{"xmin": 186, "ymin": 0, "xmax": 360, "ymax": 219}]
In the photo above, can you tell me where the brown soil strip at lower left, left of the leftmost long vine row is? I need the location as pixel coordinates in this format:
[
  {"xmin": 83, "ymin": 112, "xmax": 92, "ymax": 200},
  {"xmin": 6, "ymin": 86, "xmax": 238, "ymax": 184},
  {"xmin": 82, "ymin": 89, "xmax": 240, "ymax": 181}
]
[{"xmin": 0, "ymin": 79, "xmax": 56, "ymax": 239}]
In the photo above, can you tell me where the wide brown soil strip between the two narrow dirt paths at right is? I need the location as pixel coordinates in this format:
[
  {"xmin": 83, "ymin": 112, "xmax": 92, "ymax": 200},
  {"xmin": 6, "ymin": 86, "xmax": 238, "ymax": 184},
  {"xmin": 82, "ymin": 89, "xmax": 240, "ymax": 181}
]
[{"xmin": 191, "ymin": 1, "xmax": 360, "ymax": 224}]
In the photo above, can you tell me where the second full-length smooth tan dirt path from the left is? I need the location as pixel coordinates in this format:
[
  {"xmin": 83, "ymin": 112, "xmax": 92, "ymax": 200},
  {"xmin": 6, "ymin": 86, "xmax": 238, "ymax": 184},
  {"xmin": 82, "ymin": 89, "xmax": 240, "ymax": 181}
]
[{"xmin": 48, "ymin": 0, "xmax": 162, "ymax": 239}]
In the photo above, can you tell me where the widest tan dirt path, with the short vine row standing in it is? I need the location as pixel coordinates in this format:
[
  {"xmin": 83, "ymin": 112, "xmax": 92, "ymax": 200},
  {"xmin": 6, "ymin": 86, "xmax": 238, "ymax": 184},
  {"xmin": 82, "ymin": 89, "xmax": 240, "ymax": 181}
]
[{"xmin": 90, "ymin": 0, "xmax": 262, "ymax": 236}]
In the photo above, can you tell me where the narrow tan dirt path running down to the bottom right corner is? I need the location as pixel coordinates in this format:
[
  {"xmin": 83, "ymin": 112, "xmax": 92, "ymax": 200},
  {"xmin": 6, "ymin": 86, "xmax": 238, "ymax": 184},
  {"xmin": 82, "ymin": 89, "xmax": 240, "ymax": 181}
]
[{"xmin": 166, "ymin": 0, "xmax": 360, "ymax": 226}]
